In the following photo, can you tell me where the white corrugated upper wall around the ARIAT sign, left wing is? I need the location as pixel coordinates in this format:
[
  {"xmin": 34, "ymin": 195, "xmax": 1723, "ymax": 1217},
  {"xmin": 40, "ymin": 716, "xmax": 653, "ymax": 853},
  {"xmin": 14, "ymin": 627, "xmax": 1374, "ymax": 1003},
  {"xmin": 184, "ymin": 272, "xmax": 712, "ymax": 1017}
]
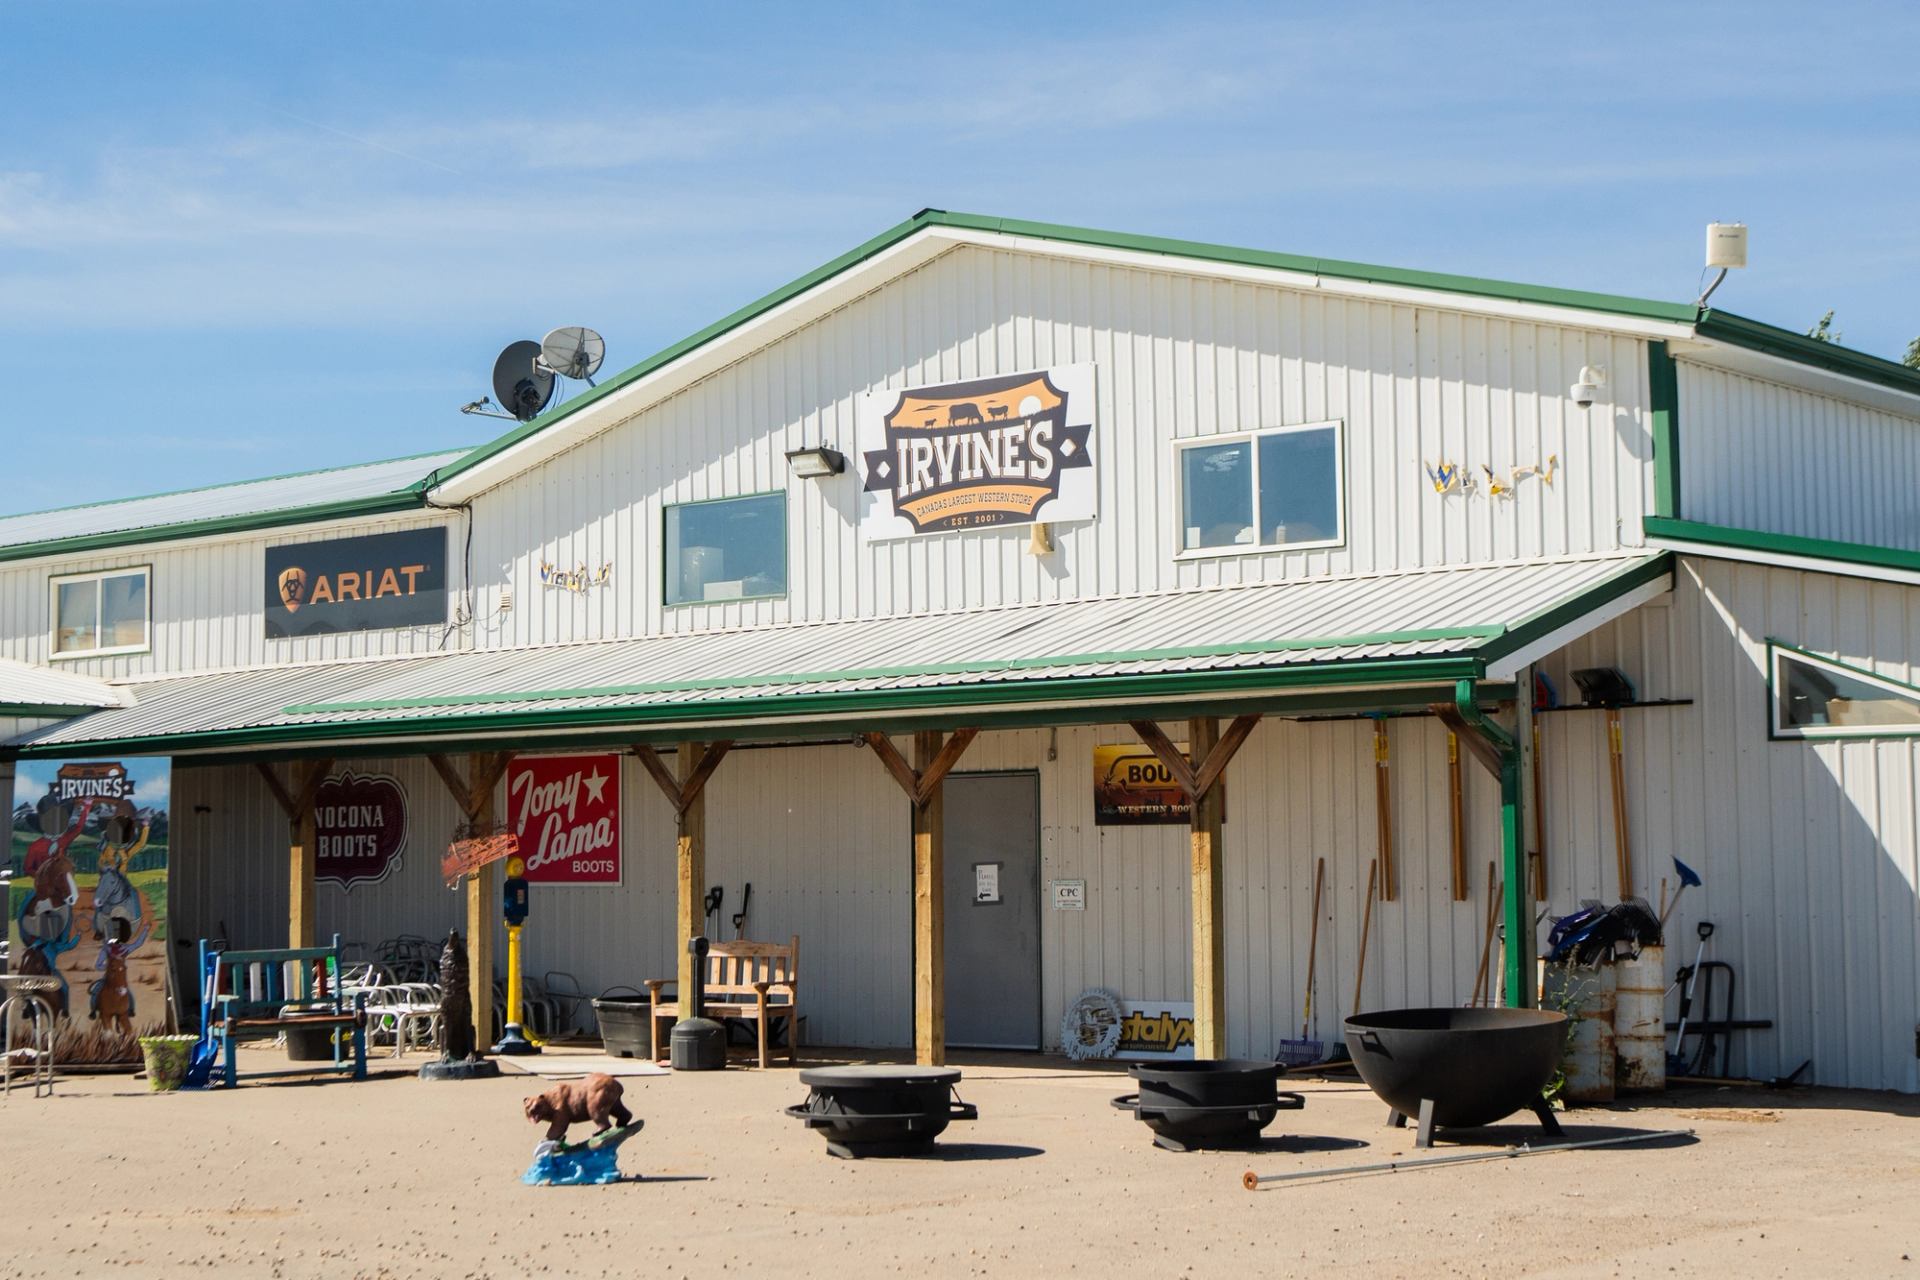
[{"xmin": 0, "ymin": 514, "xmax": 465, "ymax": 679}]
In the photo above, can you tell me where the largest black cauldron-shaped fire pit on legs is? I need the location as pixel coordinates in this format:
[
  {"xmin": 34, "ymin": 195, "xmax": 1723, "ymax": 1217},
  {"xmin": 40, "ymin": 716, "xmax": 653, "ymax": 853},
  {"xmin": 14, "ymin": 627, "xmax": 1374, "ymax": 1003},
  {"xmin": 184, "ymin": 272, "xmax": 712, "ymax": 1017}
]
[{"xmin": 1346, "ymin": 1009, "xmax": 1567, "ymax": 1148}]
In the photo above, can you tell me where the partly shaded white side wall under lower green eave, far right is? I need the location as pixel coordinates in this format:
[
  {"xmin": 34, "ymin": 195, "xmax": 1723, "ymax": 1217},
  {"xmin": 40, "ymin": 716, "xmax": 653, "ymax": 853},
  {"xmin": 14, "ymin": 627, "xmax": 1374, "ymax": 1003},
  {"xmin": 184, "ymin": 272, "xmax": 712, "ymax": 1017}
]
[{"xmin": 1542, "ymin": 557, "xmax": 1920, "ymax": 1092}]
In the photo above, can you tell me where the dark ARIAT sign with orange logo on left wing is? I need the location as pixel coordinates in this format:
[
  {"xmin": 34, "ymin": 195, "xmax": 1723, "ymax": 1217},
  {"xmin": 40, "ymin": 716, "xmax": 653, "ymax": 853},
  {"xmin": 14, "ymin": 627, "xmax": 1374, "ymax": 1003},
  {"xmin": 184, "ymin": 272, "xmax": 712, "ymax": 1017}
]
[{"xmin": 265, "ymin": 528, "xmax": 447, "ymax": 639}]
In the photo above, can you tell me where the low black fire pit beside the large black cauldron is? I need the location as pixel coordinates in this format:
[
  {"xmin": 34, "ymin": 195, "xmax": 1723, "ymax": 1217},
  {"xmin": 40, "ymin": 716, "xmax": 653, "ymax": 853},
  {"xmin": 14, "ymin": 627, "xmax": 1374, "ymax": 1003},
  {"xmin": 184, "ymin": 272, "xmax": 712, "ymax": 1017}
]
[{"xmin": 1114, "ymin": 1057, "xmax": 1306, "ymax": 1151}]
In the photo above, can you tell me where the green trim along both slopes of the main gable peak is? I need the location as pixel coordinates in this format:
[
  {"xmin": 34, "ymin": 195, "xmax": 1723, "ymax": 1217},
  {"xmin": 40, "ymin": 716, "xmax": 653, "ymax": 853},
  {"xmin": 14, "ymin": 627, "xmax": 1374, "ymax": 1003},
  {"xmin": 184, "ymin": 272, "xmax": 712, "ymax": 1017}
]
[{"xmin": 422, "ymin": 209, "xmax": 1697, "ymax": 487}]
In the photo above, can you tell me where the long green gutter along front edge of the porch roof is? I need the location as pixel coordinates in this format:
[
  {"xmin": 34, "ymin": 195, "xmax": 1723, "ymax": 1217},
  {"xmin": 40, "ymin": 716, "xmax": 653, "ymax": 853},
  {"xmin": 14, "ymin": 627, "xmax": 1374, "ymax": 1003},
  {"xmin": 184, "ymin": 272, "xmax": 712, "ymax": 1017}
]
[{"xmin": 15, "ymin": 656, "xmax": 1482, "ymax": 760}]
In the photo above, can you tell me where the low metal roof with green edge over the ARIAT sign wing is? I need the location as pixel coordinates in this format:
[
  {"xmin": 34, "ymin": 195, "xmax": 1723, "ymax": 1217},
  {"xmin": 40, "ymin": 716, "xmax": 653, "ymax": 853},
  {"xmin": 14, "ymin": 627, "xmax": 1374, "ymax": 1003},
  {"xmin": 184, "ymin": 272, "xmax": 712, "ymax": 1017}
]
[{"xmin": 0, "ymin": 449, "xmax": 468, "ymax": 560}]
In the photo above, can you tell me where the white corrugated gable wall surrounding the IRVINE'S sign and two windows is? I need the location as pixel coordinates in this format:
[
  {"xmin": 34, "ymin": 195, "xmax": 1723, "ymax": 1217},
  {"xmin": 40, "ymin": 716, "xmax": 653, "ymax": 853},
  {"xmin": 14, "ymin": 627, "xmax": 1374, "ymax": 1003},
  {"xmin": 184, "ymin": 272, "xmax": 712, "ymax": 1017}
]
[{"xmin": 474, "ymin": 239, "xmax": 1651, "ymax": 645}]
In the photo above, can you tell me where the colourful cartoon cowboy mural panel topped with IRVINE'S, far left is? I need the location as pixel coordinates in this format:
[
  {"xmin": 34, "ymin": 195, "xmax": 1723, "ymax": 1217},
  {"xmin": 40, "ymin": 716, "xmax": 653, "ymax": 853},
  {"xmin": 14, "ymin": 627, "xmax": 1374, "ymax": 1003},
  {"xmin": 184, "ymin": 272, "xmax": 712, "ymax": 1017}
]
[{"xmin": 8, "ymin": 760, "xmax": 173, "ymax": 1065}]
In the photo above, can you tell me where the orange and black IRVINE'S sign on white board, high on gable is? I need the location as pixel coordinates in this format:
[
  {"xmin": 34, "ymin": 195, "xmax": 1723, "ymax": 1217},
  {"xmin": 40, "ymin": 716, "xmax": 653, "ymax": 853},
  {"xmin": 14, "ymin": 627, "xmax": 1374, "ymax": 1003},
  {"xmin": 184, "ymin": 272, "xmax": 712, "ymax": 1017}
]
[{"xmin": 858, "ymin": 365, "xmax": 1098, "ymax": 539}]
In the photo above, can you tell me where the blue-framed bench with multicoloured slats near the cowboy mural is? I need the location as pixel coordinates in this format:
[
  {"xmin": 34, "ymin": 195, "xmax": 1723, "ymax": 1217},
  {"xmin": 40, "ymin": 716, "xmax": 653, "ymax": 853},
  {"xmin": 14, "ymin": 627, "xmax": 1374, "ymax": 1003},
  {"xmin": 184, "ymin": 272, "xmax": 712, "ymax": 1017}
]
[{"xmin": 200, "ymin": 935, "xmax": 367, "ymax": 1088}]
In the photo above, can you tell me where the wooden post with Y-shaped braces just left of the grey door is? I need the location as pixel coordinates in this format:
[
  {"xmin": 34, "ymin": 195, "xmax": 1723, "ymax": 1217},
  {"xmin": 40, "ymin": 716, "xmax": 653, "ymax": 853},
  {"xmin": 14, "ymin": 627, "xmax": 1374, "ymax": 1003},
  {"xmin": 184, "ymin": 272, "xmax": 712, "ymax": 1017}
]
[{"xmin": 866, "ymin": 729, "xmax": 979, "ymax": 1067}]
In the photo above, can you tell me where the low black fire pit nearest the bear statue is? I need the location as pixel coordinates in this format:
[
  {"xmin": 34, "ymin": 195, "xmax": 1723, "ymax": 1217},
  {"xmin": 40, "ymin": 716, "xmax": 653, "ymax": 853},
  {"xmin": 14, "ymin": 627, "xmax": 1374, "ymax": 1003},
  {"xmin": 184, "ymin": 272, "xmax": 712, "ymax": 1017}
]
[{"xmin": 787, "ymin": 1067, "xmax": 979, "ymax": 1159}]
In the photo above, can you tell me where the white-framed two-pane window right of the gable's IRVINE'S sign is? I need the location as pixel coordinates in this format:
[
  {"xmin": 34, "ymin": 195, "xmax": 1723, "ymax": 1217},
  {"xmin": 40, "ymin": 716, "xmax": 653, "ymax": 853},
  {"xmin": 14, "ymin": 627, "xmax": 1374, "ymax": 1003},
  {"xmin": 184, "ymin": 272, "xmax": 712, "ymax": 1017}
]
[{"xmin": 1173, "ymin": 420, "xmax": 1346, "ymax": 558}]
